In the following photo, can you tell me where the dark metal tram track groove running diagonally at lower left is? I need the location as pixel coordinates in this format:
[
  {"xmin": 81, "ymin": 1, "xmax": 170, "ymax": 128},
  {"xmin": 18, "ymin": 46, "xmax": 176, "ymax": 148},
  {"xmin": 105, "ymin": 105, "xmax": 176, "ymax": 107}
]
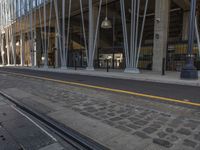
[{"xmin": 0, "ymin": 91, "xmax": 109, "ymax": 150}]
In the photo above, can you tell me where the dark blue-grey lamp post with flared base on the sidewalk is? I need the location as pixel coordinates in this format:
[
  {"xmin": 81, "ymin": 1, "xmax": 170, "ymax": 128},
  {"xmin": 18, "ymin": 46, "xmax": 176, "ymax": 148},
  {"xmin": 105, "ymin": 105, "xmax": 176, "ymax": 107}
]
[{"xmin": 181, "ymin": 0, "xmax": 198, "ymax": 79}]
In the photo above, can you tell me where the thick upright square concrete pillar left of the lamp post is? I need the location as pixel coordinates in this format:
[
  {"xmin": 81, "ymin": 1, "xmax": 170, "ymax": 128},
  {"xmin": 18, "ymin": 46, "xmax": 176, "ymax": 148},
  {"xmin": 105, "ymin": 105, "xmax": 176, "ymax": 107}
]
[{"xmin": 153, "ymin": 0, "xmax": 170, "ymax": 73}]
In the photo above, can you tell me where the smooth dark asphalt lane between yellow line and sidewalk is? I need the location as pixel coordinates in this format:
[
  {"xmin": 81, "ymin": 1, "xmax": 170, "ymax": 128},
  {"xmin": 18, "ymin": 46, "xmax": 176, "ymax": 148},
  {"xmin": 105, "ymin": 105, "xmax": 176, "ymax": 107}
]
[{"xmin": 0, "ymin": 68, "xmax": 200, "ymax": 103}]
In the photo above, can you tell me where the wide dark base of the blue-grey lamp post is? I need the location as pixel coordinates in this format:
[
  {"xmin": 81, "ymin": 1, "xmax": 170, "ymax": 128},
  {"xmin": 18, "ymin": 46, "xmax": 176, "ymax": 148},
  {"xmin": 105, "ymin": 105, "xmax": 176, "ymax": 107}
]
[{"xmin": 181, "ymin": 64, "xmax": 198, "ymax": 80}]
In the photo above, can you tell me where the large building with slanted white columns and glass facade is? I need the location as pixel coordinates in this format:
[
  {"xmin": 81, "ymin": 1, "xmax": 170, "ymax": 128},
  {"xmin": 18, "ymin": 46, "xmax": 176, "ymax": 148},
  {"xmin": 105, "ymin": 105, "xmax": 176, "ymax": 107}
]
[{"xmin": 0, "ymin": 0, "xmax": 200, "ymax": 72}]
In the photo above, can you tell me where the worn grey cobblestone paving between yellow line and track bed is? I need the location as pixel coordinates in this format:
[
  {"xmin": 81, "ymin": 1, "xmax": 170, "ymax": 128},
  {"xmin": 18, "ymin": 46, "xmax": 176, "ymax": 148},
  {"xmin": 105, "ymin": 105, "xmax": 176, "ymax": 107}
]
[{"xmin": 0, "ymin": 74, "xmax": 200, "ymax": 150}]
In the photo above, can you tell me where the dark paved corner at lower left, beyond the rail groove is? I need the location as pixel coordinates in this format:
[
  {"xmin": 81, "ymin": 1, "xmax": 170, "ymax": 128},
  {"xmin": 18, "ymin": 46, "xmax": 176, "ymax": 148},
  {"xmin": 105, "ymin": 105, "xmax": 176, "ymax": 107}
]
[{"xmin": 0, "ymin": 96, "xmax": 64, "ymax": 150}]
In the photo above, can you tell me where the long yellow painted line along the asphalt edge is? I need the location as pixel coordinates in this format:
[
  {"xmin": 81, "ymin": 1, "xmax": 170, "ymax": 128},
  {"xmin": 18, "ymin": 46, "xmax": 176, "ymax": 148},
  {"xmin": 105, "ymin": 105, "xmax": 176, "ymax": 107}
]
[{"xmin": 1, "ymin": 71, "xmax": 200, "ymax": 107}]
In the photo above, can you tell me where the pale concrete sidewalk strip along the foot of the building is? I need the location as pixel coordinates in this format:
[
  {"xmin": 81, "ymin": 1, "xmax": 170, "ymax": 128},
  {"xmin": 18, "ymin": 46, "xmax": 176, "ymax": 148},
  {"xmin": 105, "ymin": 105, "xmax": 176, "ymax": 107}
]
[{"xmin": 2, "ymin": 66, "xmax": 200, "ymax": 86}]
